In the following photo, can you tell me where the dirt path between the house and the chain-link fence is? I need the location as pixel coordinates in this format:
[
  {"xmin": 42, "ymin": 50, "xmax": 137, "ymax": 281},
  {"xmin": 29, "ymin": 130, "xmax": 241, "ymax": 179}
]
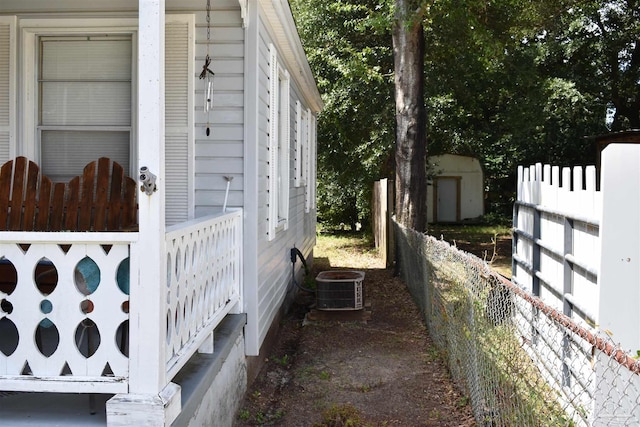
[{"xmin": 236, "ymin": 239, "xmax": 475, "ymax": 427}]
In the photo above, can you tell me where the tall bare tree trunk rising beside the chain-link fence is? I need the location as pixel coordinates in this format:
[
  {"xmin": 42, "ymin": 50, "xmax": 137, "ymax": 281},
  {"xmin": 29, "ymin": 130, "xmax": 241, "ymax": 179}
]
[{"xmin": 393, "ymin": 0, "xmax": 427, "ymax": 232}]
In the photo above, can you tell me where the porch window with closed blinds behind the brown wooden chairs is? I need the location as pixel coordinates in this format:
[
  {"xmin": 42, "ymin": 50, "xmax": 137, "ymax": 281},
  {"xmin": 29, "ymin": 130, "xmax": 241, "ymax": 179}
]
[{"xmin": 37, "ymin": 34, "xmax": 133, "ymax": 181}]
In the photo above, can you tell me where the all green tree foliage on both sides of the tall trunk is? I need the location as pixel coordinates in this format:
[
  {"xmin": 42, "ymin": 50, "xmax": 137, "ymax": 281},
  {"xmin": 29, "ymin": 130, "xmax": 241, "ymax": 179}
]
[{"xmin": 291, "ymin": 0, "xmax": 640, "ymax": 228}]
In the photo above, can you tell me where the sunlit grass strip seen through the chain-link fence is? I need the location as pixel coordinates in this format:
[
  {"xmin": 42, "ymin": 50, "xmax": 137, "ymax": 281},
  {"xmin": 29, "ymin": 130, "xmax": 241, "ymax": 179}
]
[{"xmin": 436, "ymin": 263, "xmax": 574, "ymax": 426}]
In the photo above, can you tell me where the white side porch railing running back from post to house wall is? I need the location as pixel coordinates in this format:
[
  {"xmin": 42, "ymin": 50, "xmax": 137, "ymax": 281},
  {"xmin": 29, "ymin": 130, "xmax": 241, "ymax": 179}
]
[{"xmin": 166, "ymin": 211, "xmax": 242, "ymax": 378}]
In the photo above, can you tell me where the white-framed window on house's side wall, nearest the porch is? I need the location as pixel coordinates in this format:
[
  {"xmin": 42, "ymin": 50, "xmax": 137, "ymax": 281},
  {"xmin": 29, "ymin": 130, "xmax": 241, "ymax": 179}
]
[{"xmin": 268, "ymin": 45, "xmax": 290, "ymax": 239}]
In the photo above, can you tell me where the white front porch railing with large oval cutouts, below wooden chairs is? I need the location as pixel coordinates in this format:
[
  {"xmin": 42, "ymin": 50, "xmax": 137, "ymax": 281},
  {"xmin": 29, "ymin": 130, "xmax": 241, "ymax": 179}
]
[{"xmin": 0, "ymin": 232, "xmax": 133, "ymax": 393}]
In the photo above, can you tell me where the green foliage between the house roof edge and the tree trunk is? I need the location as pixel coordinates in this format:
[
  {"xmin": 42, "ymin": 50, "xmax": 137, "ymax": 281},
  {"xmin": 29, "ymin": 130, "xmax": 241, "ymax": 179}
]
[{"xmin": 291, "ymin": 0, "xmax": 394, "ymax": 229}]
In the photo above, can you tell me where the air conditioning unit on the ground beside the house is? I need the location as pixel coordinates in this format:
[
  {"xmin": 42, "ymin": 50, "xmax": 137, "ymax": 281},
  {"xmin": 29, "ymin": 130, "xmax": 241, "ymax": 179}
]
[{"xmin": 316, "ymin": 270, "xmax": 364, "ymax": 310}]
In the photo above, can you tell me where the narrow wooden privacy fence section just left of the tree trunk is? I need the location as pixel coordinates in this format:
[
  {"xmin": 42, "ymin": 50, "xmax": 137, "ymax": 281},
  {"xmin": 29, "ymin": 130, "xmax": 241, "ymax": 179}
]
[{"xmin": 371, "ymin": 178, "xmax": 394, "ymax": 267}]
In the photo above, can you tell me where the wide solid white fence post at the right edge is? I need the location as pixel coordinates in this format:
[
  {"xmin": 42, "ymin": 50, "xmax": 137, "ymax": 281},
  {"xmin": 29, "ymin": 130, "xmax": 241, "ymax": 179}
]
[{"xmin": 593, "ymin": 143, "xmax": 640, "ymax": 426}]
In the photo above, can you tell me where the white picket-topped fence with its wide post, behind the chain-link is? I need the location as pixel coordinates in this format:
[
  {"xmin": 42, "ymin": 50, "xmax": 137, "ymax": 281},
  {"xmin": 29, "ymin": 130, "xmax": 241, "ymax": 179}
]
[{"xmin": 512, "ymin": 149, "xmax": 640, "ymax": 426}]
